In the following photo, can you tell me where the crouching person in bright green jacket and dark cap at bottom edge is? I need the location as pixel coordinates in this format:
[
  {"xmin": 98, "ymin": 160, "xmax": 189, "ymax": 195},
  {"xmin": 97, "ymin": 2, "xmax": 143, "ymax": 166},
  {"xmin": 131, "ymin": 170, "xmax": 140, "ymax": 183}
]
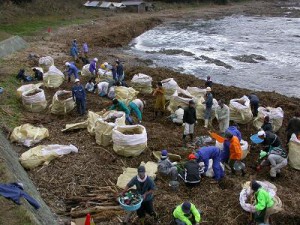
[{"xmin": 173, "ymin": 202, "xmax": 201, "ymax": 225}]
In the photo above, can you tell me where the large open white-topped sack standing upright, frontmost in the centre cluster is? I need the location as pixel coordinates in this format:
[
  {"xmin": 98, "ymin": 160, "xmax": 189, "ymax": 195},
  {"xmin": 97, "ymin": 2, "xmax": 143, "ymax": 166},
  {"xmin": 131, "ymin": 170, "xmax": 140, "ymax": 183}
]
[{"xmin": 112, "ymin": 125, "xmax": 147, "ymax": 157}]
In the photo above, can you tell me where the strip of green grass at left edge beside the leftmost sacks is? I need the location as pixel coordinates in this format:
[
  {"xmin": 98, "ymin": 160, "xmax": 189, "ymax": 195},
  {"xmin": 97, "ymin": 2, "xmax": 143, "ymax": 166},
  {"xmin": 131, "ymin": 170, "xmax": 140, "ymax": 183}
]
[{"xmin": 0, "ymin": 75, "xmax": 22, "ymax": 128}]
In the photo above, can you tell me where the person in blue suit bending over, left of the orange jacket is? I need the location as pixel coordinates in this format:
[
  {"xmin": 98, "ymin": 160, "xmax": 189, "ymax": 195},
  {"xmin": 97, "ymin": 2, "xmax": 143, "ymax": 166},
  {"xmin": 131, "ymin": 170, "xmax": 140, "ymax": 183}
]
[{"xmin": 195, "ymin": 146, "xmax": 224, "ymax": 182}]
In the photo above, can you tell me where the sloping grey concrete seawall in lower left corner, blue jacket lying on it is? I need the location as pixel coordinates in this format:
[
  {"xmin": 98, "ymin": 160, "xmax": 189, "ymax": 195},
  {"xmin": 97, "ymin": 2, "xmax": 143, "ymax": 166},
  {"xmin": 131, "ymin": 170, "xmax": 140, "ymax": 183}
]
[{"xmin": 0, "ymin": 131, "xmax": 58, "ymax": 225}]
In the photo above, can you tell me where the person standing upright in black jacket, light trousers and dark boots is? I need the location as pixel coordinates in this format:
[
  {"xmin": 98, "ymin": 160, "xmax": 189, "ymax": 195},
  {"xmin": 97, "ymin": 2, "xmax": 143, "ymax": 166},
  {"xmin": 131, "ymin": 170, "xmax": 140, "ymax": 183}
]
[{"xmin": 182, "ymin": 100, "xmax": 197, "ymax": 147}]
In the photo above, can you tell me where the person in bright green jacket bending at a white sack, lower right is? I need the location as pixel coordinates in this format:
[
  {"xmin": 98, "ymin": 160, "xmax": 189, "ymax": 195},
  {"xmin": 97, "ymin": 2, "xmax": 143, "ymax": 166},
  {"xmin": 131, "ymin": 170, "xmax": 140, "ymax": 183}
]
[{"xmin": 251, "ymin": 180, "xmax": 277, "ymax": 225}]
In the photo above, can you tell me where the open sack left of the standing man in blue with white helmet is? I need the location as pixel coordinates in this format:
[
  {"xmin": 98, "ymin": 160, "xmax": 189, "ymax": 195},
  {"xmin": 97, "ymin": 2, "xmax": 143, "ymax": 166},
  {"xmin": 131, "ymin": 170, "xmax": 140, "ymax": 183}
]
[{"xmin": 50, "ymin": 90, "xmax": 75, "ymax": 115}]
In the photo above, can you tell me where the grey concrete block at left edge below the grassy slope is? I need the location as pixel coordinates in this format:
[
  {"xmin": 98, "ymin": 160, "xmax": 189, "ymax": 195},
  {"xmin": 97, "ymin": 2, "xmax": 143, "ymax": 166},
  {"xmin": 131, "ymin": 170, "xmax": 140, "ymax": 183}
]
[{"xmin": 0, "ymin": 36, "xmax": 28, "ymax": 58}]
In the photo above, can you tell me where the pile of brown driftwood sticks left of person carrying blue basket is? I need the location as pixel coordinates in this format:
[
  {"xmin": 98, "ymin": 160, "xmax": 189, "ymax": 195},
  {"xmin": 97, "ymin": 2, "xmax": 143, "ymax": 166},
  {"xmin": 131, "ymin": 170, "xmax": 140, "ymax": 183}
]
[{"xmin": 65, "ymin": 185, "xmax": 125, "ymax": 222}]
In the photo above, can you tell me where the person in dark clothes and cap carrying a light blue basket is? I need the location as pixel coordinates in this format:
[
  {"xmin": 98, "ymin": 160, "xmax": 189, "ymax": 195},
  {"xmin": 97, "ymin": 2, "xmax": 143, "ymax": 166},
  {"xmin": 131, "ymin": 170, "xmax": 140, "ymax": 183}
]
[{"xmin": 122, "ymin": 166, "xmax": 157, "ymax": 225}]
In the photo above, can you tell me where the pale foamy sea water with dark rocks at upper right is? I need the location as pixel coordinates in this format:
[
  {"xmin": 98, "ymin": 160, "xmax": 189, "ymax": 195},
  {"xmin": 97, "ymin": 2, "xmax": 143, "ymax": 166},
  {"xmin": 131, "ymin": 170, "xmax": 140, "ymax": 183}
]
[{"xmin": 127, "ymin": 16, "xmax": 300, "ymax": 97}]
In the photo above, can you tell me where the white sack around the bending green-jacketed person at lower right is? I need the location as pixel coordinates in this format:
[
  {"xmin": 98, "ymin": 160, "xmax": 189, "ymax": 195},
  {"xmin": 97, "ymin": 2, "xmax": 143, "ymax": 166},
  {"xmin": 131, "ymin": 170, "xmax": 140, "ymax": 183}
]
[{"xmin": 240, "ymin": 181, "xmax": 282, "ymax": 212}]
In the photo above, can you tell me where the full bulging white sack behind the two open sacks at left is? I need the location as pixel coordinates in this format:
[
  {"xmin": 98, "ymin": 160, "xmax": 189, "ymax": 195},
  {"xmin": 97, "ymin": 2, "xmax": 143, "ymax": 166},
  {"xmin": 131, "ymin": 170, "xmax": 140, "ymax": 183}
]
[{"xmin": 43, "ymin": 66, "xmax": 65, "ymax": 88}]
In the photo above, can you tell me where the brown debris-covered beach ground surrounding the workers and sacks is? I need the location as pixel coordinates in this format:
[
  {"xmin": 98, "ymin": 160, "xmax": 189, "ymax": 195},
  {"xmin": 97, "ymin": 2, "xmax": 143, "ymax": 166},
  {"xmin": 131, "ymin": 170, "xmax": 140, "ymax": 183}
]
[{"xmin": 0, "ymin": 1, "xmax": 300, "ymax": 225}]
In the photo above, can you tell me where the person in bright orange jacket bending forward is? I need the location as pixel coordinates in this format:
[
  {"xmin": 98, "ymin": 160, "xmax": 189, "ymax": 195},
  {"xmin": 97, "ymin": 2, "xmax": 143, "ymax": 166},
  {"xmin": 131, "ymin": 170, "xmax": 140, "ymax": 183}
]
[{"xmin": 225, "ymin": 132, "xmax": 246, "ymax": 176}]
